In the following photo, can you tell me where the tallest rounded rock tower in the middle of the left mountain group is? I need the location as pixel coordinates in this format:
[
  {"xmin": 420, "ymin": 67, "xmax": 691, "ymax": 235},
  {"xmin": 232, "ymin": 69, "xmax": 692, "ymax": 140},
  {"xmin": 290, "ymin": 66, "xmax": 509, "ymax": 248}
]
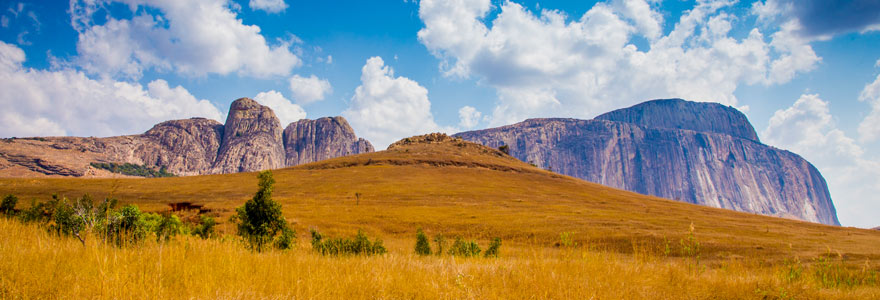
[{"xmin": 213, "ymin": 98, "xmax": 285, "ymax": 173}]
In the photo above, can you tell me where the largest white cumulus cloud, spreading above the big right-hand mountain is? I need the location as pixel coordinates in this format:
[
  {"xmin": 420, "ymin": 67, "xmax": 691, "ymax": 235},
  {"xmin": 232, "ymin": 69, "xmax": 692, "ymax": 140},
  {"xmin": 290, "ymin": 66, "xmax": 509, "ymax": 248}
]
[{"xmin": 418, "ymin": 0, "xmax": 820, "ymax": 125}]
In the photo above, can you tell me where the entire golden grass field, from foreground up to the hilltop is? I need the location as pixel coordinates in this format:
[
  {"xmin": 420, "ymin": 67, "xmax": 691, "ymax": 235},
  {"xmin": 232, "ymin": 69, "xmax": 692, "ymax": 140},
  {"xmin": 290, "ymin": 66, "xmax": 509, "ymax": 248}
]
[{"xmin": 0, "ymin": 135, "xmax": 880, "ymax": 299}]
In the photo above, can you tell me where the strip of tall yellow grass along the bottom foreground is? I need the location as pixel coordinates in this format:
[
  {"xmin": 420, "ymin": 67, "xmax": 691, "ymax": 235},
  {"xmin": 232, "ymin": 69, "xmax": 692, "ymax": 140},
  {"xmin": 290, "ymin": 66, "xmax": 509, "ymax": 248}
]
[{"xmin": 0, "ymin": 218, "xmax": 880, "ymax": 299}]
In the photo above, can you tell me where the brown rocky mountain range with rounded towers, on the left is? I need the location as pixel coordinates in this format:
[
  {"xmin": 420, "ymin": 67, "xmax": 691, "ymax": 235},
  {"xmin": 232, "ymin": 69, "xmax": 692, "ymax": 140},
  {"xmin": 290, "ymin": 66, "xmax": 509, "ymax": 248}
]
[{"xmin": 0, "ymin": 98, "xmax": 374, "ymax": 177}]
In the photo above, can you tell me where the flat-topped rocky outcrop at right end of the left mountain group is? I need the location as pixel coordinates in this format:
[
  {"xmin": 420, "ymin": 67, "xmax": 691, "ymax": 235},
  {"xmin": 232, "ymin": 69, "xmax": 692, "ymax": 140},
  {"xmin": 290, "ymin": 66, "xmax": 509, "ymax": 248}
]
[{"xmin": 283, "ymin": 117, "xmax": 374, "ymax": 166}]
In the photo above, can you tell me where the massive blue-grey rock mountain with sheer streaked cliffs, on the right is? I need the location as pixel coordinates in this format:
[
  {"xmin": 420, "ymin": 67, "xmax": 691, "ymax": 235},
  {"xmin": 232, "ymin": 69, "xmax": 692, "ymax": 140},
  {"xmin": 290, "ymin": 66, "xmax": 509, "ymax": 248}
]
[{"xmin": 456, "ymin": 99, "xmax": 839, "ymax": 225}]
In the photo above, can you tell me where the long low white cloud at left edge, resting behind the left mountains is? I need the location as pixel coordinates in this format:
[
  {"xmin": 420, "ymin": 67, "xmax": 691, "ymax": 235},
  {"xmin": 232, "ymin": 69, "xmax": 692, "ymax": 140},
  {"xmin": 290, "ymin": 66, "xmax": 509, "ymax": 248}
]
[{"xmin": 0, "ymin": 42, "xmax": 221, "ymax": 136}]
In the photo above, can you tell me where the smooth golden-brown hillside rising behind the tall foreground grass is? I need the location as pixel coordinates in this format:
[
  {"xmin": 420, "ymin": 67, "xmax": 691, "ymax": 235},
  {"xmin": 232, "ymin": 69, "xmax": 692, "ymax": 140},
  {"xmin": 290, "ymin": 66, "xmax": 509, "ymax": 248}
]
[{"xmin": 0, "ymin": 134, "xmax": 880, "ymax": 261}]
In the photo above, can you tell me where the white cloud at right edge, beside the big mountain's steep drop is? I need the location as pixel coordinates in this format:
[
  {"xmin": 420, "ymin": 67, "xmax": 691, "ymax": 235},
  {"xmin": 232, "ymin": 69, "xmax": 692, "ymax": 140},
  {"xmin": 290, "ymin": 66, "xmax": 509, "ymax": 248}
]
[{"xmin": 761, "ymin": 95, "xmax": 880, "ymax": 228}]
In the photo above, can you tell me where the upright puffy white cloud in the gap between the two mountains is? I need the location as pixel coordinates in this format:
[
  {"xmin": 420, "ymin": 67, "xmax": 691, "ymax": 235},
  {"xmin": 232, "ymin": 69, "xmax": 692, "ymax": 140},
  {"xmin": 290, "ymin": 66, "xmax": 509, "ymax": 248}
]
[{"xmin": 342, "ymin": 57, "xmax": 442, "ymax": 149}]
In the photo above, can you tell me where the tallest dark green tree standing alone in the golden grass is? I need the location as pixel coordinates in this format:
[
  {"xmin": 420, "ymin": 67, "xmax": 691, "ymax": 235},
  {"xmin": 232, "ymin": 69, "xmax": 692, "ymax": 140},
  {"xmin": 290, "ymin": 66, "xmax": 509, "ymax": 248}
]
[{"xmin": 233, "ymin": 171, "xmax": 290, "ymax": 251}]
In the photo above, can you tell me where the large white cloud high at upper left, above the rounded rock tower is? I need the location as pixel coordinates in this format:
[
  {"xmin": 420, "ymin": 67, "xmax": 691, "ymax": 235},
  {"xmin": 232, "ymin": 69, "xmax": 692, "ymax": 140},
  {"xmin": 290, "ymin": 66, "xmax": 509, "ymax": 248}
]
[{"xmin": 70, "ymin": 0, "xmax": 301, "ymax": 78}]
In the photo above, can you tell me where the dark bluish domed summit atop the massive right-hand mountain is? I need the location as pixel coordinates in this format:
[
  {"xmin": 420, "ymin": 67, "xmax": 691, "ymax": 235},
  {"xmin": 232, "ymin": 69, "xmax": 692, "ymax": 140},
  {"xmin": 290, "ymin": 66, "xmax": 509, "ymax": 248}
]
[{"xmin": 596, "ymin": 99, "xmax": 759, "ymax": 142}]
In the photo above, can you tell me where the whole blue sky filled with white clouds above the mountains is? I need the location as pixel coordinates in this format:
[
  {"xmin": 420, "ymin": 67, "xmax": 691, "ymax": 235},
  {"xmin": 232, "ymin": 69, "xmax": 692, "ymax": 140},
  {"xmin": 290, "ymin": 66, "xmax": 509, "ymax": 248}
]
[{"xmin": 0, "ymin": 0, "xmax": 880, "ymax": 228}]
